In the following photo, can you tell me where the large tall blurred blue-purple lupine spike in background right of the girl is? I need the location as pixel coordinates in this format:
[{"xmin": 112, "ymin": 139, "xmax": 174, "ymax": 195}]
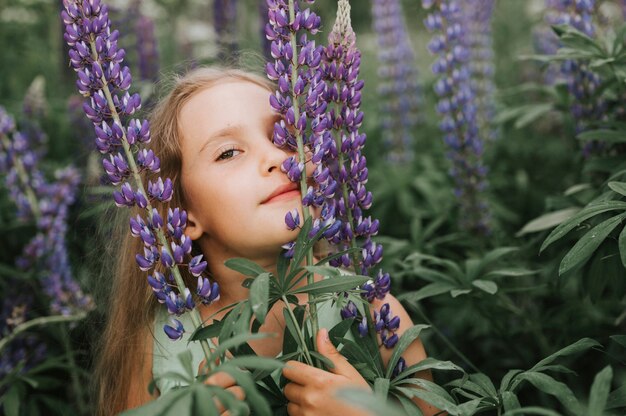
[{"xmin": 422, "ymin": 0, "xmax": 489, "ymax": 234}]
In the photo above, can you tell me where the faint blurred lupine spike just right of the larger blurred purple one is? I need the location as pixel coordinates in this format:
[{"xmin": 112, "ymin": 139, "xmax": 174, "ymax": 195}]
[{"xmin": 462, "ymin": 0, "xmax": 496, "ymax": 140}]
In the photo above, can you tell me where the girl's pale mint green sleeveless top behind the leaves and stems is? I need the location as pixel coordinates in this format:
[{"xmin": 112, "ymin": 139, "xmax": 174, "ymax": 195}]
[{"xmin": 152, "ymin": 300, "xmax": 349, "ymax": 395}]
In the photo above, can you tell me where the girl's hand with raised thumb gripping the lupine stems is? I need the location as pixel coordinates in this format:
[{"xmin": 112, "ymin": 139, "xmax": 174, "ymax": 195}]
[{"xmin": 283, "ymin": 329, "xmax": 370, "ymax": 416}]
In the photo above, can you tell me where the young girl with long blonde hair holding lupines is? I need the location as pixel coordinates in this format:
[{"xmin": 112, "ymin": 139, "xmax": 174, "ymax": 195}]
[{"xmin": 96, "ymin": 69, "xmax": 435, "ymax": 415}]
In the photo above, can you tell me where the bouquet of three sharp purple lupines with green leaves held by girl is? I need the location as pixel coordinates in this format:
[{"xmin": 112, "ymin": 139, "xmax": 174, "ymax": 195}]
[{"xmin": 62, "ymin": 0, "xmax": 452, "ymax": 414}]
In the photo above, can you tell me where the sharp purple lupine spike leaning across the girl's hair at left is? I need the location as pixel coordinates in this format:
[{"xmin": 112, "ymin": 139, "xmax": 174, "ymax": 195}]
[{"xmin": 61, "ymin": 0, "xmax": 219, "ymax": 339}]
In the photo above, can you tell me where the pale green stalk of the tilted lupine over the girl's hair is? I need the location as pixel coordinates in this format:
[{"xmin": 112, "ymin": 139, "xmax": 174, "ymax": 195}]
[{"xmin": 89, "ymin": 38, "xmax": 215, "ymax": 370}]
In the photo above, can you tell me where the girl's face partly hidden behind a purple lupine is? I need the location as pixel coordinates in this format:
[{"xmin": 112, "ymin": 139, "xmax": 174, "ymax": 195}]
[{"xmin": 179, "ymin": 80, "xmax": 302, "ymax": 259}]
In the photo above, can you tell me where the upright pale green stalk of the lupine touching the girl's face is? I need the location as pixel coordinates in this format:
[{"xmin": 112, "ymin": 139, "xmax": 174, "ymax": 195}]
[{"xmin": 289, "ymin": 0, "xmax": 319, "ymax": 342}]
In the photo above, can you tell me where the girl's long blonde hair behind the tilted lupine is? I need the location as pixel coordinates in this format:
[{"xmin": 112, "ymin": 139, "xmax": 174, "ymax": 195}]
[{"xmin": 94, "ymin": 68, "xmax": 273, "ymax": 416}]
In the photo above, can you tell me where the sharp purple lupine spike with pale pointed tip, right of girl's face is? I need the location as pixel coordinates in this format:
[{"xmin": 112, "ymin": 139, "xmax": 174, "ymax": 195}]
[{"xmin": 322, "ymin": 0, "xmax": 400, "ymax": 348}]
